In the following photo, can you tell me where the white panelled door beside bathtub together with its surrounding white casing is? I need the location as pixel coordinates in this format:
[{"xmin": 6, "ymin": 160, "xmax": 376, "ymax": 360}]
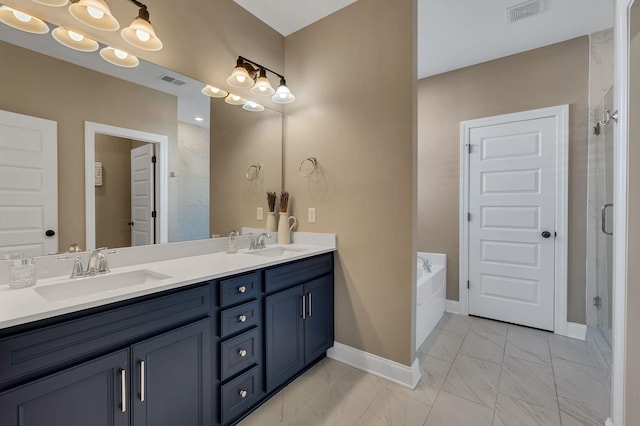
[{"xmin": 460, "ymin": 105, "xmax": 568, "ymax": 335}]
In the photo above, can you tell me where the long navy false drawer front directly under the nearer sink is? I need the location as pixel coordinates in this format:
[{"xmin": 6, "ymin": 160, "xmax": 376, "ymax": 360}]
[{"xmin": 0, "ymin": 286, "xmax": 211, "ymax": 388}]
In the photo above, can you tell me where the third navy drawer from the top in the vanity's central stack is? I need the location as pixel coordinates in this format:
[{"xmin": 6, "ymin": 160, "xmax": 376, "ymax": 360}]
[{"xmin": 220, "ymin": 328, "xmax": 262, "ymax": 381}]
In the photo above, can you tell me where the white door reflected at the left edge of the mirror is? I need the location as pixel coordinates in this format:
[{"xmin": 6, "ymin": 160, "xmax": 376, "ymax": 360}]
[{"xmin": 0, "ymin": 111, "xmax": 58, "ymax": 259}]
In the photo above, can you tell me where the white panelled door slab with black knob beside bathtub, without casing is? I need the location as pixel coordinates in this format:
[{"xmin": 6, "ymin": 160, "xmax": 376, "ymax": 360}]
[{"xmin": 468, "ymin": 110, "xmax": 558, "ymax": 330}]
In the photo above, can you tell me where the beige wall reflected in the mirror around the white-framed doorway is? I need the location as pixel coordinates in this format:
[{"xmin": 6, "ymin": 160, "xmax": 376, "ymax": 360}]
[{"xmin": 0, "ymin": 42, "xmax": 177, "ymax": 250}]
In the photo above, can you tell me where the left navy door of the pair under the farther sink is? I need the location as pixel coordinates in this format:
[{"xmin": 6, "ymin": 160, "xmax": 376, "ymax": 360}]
[{"xmin": 265, "ymin": 285, "xmax": 304, "ymax": 392}]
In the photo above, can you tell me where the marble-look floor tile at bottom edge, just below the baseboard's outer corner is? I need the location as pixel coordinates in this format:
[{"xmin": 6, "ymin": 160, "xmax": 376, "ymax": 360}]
[{"xmin": 356, "ymin": 389, "xmax": 431, "ymax": 426}]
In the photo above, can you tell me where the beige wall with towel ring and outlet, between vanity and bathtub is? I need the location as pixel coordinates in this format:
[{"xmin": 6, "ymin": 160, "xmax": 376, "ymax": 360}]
[{"xmin": 284, "ymin": 0, "xmax": 415, "ymax": 365}]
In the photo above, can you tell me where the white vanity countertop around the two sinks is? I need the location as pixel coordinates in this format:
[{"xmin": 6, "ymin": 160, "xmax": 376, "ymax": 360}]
[{"xmin": 0, "ymin": 244, "xmax": 336, "ymax": 329}]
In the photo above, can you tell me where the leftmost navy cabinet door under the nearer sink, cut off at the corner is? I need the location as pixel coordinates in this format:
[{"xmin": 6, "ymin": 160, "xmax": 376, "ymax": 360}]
[{"xmin": 0, "ymin": 349, "xmax": 130, "ymax": 426}]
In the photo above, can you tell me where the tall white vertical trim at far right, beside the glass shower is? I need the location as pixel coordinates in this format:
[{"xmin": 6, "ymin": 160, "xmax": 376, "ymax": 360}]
[{"xmin": 611, "ymin": 0, "xmax": 634, "ymax": 425}]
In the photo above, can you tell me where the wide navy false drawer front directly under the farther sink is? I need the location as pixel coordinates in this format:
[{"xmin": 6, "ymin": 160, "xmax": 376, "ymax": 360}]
[{"xmin": 265, "ymin": 253, "xmax": 333, "ymax": 293}]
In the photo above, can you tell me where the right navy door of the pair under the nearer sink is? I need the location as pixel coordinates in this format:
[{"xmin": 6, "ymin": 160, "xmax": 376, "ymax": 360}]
[{"xmin": 131, "ymin": 318, "xmax": 213, "ymax": 426}]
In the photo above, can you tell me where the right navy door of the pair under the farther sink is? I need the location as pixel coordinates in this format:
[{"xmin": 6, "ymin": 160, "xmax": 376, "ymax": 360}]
[{"xmin": 304, "ymin": 275, "xmax": 333, "ymax": 364}]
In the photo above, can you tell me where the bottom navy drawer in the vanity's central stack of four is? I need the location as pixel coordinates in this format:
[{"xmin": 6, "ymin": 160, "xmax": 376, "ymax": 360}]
[{"xmin": 220, "ymin": 366, "xmax": 263, "ymax": 424}]
